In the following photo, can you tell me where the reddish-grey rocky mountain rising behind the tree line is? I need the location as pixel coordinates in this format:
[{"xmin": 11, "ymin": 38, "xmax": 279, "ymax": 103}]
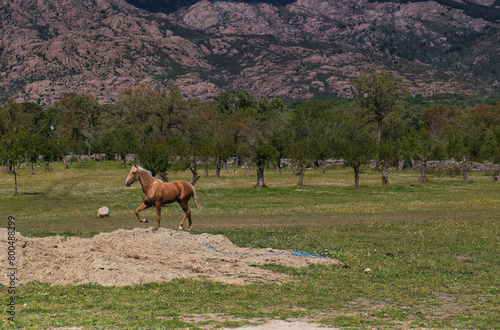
[{"xmin": 0, "ymin": 0, "xmax": 500, "ymax": 106}]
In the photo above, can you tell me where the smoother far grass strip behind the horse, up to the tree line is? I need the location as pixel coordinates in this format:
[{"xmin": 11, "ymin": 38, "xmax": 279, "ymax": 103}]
[{"xmin": 0, "ymin": 162, "xmax": 500, "ymax": 232}]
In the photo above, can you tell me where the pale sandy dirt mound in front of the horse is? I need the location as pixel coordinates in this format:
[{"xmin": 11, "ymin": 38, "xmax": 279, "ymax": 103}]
[{"xmin": 0, "ymin": 228, "xmax": 337, "ymax": 286}]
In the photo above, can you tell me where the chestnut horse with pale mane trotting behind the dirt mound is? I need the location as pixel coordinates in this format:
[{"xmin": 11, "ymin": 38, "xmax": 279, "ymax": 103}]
[{"xmin": 125, "ymin": 164, "xmax": 201, "ymax": 230}]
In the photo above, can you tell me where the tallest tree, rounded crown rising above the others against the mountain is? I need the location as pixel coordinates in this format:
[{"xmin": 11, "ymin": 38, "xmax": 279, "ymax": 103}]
[{"xmin": 353, "ymin": 71, "xmax": 409, "ymax": 184}]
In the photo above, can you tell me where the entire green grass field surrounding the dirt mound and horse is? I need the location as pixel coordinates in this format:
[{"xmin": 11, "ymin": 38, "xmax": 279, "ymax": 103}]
[{"xmin": 0, "ymin": 162, "xmax": 500, "ymax": 329}]
